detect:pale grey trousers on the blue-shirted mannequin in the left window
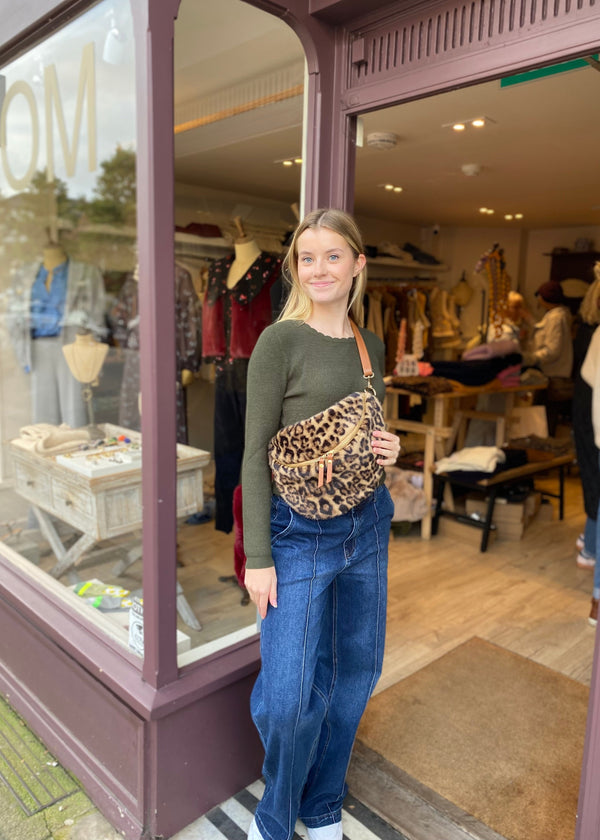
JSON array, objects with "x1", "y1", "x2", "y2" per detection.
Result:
[{"x1": 31, "y1": 335, "x2": 89, "y2": 429}]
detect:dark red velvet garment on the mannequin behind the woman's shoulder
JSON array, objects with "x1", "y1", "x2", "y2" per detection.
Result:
[{"x1": 202, "y1": 253, "x2": 281, "y2": 361}]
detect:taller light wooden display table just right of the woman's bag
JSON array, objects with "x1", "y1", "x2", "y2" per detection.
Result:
[{"x1": 384, "y1": 379, "x2": 546, "y2": 540}]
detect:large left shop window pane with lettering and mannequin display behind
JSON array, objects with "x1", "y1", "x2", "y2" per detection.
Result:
[{"x1": 0, "y1": 0, "x2": 142, "y2": 646}]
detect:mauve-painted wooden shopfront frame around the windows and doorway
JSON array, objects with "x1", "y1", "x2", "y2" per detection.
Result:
[{"x1": 0, "y1": 0, "x2": 600, "y2": 840}]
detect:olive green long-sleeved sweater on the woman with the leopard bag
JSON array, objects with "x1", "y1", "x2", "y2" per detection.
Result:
[{"x1": 242, "y1": 321, "x2": 385, "y2": 569}]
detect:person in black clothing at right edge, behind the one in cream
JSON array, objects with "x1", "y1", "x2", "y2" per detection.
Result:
[{"x1": 572, "y1": 276, "x2": 600, "y2": 569}]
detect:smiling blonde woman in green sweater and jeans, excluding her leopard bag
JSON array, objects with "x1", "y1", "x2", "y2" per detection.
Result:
[{"x1": 242, "y1": 210, "x2": 400, "y2": 840}]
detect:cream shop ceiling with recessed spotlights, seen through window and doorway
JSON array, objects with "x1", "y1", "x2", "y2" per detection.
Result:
[{"x1": 175, "y1": 0, "x2": 600, "y2": 229}]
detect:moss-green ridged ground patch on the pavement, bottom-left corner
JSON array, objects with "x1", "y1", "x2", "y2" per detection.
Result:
[{"x1": 0, "y1": 698, "x2": 80, "y2": 817}]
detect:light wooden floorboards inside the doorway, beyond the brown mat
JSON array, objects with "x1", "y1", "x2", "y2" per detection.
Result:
[{"x1": 377, "y1": 475, "x2": 595, "y2": 691}]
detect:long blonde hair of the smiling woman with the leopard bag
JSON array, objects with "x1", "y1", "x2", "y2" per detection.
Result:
[{"x1": 278, "y1": 208, "x2": 367, "y2": 327}]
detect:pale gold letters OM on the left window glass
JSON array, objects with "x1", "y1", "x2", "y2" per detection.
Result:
[{"x1": 0, "y1": 42, "x2": 97, "y2": 190}]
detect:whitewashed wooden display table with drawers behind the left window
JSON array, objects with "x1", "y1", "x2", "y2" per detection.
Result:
[{"x1": 9, "y1": 423, "x2": 210, "y2": 628}]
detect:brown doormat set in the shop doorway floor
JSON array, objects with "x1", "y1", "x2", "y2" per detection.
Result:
[{"x1": 358, "y1": 637, "x2": 589, "y2": 840}]
